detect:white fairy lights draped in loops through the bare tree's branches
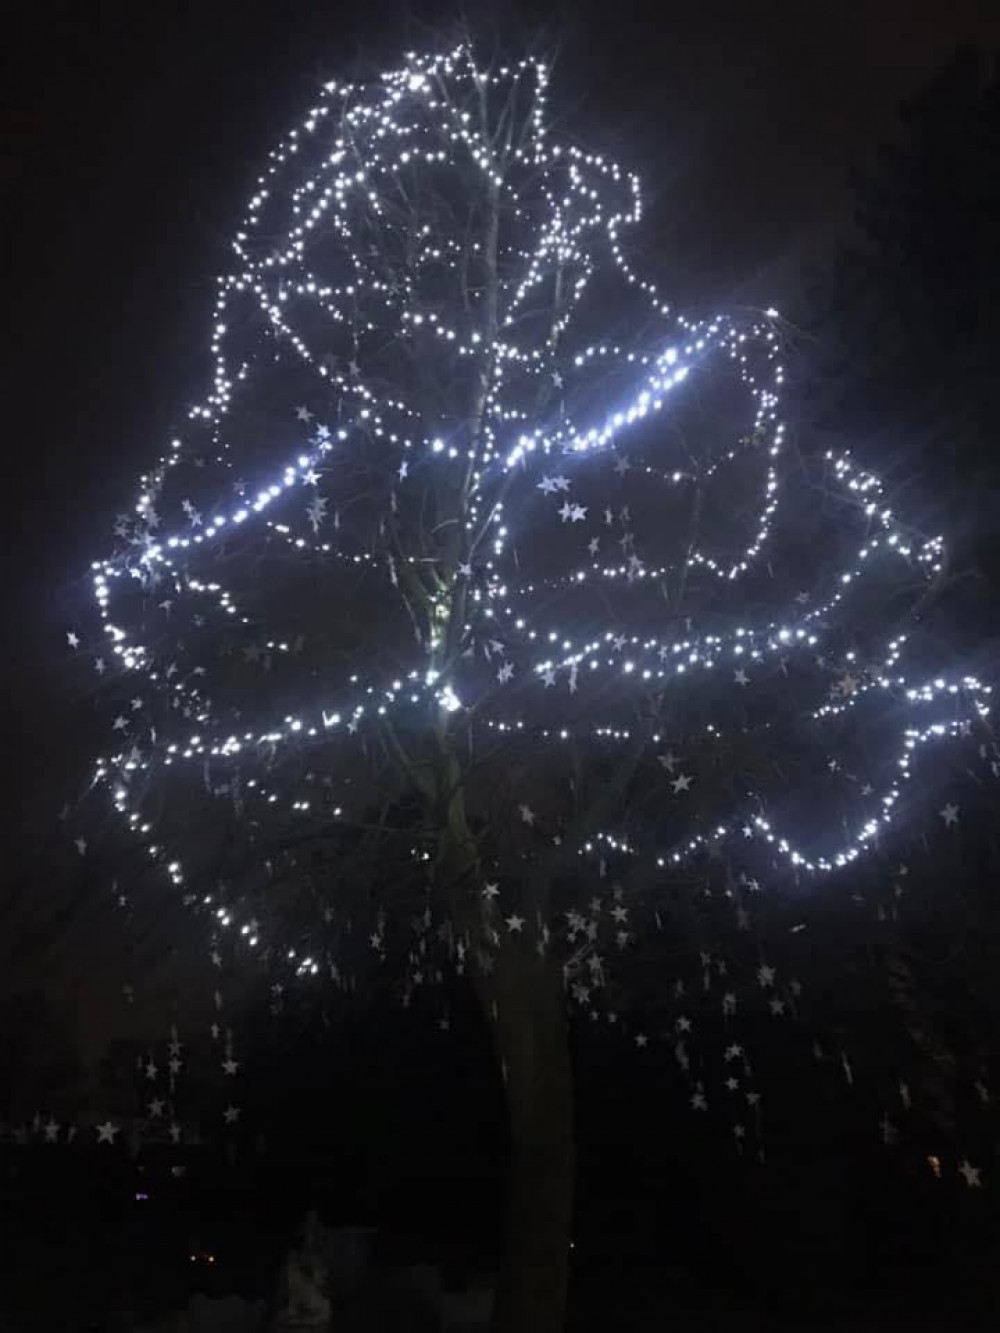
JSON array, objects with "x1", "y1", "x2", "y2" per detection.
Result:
[{"x1": 68, "y1": 47, "x2": 997, "y2": 973}]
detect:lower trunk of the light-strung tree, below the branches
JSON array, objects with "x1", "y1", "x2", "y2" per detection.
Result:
[{"x1": 485, "y1": 940, "x2": 575, "y2": 1333}]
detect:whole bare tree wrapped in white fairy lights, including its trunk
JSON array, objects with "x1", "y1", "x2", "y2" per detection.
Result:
[{"x1": 71, "y1": 45, "x2": 985, "y2": 1333}]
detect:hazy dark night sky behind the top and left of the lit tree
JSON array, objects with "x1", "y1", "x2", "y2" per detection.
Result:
[{"x1": 0, "y1": 0, "x2": 1000, "y2": 865}]
